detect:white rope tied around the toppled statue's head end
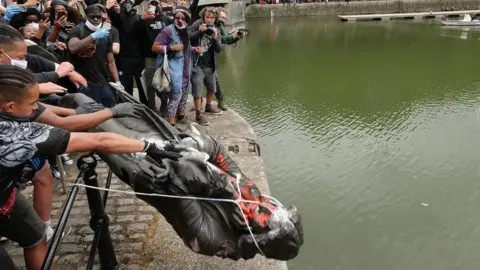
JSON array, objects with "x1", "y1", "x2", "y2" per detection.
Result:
[{"x1": 73, "y1": 174, "x2": 272, "y2": 256}]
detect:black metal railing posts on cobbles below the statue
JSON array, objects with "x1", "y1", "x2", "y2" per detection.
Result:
[{"x1": 42, "y1": 154, "x2": 118, "y2": 270}]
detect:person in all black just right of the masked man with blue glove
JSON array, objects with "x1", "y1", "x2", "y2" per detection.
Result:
[{"x1": 106, "y1": 0, "x2": 148, "y2": 106}]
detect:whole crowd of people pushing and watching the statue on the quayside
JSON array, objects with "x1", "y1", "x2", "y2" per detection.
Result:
[{"x1": 0, "y1": 0, "x2": 247, "y2": 269}]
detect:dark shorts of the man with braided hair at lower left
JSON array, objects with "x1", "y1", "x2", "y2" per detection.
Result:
[{"x1": 0, "y1": 189, "x2": 46, "y2": 248}]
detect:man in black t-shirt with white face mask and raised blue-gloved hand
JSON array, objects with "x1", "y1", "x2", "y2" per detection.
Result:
[{"x1": 68, "y1": 5, "x2": 123, "y2": 108}]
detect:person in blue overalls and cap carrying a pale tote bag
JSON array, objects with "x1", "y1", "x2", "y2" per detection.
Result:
[{"x1": 152, "y1": 7, "x2": 199, "y2": 125}]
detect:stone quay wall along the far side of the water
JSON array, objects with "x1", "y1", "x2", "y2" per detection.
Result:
[{"x1": 246, "y1": 0, "x2": 480, "y2": 18}]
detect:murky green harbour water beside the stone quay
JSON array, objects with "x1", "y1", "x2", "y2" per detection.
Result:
[{"x1": 218, "y1": 18, "x2": 480, "y2": 270}]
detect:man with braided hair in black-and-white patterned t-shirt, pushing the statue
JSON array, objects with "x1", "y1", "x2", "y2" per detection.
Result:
[{"x1": 0, "y1": 65, "x2": 181, "y2": 269}]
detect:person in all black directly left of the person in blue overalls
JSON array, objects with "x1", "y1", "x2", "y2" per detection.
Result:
[{"x1": 132, "y1": 0, "x2": 172, "y2": 110}]
